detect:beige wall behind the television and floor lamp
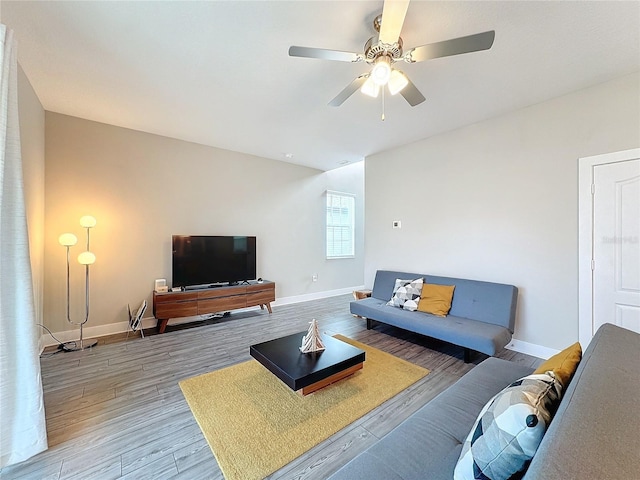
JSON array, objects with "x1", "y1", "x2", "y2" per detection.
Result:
[{"x1": 45, "y1": 112, "x2": 364, "y2": 332}]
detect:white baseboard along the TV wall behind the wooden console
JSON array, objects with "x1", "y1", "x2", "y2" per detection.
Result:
[{"x1": 40, "y1": 285, "x2": 364, "y2": 353}]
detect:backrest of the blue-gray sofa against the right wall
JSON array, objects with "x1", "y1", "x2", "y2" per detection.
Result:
[{"x1": 368, "y1": 270, "x2": 518, "y2": 333}]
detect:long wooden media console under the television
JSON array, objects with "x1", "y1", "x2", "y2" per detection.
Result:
[{"x1": 153, "y1": 280, "x2": 276, "y2": 333}]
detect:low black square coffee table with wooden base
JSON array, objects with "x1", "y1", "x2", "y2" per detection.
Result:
[{"x1": 249, "y1": 331, "x2": 365, "y2": 395}]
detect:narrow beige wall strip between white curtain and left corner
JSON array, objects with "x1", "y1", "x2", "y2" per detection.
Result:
[{"x1": 18, "y1": 67, "x2": 45, "y2": 330}]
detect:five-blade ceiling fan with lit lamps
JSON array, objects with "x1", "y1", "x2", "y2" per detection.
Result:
[{"x1": 289, "y1": 0, "x2": 496, "y2": 109}]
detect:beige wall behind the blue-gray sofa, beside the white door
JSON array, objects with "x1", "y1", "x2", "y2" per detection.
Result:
[{"x1": 365, "y1": 74, "x2": 640, "y2": 349}]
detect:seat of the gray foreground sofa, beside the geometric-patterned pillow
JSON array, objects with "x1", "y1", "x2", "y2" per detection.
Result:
[{"x1": 330, "y1": 358, "x2": 532, "y2": 480}]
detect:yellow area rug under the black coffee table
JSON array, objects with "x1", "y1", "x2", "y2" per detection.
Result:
[{"x1": 180, "y1": 335, "x2": 429, "y2": 480}]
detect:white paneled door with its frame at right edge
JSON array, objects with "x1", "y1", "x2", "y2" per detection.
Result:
[{"x1": 580, "y1": 150, "x2": 640, "y2": 347}]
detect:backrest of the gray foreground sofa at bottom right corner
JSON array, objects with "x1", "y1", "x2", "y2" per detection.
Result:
[{"x1": 524, "y1": 324, "x2": 640, "y2": 480}]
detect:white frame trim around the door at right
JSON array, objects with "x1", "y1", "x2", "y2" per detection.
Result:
[{"x1": 578, "y1": 148, "x2": 640, "y2": 349}]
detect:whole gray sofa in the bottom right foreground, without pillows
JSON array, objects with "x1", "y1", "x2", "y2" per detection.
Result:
[{"x1": 330, "y1": 324, "x2": 640, "y2": 480}]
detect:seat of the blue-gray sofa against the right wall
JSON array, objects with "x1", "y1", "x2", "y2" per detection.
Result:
[{"x1": 351, "y1": 298, "x2": 511, "y2": 355}]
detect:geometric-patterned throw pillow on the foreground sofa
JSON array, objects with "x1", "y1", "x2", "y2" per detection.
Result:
[{"x1": 453, "y1": 373, "x2": 562, "y2": 480}]
